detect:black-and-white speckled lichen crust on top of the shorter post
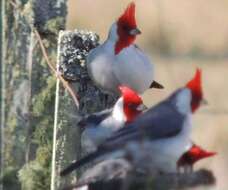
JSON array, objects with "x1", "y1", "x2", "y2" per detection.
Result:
[{"x1": 58, "y1": 30, "x2": 99, "y2": 81}]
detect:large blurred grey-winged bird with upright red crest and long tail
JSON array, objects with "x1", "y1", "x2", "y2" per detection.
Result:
[{"x1": 61, "y1": 69, "x2": 203, "y2": 176}]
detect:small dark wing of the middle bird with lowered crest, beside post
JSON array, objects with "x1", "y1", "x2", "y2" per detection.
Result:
[{"x1": 78, "y1": 108, "x2": 113, "y2": 129}]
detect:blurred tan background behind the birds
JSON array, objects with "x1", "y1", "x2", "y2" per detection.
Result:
[{"x1": 67, "y1": 0, "x2": 228, "y2": 190}]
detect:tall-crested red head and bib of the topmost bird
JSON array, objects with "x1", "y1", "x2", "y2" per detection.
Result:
[{"x1": 115, "y1": 2, "x2": 141, "y2": 54}]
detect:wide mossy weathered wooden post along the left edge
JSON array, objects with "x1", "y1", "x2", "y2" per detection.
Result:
[{"x1": 1, "y1": 0, "x2": 67, "y2": 190}]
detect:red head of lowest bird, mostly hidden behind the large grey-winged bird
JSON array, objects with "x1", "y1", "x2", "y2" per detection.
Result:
[{"x1": 177, "y1": 144, "x2": 217, "y2": 173}]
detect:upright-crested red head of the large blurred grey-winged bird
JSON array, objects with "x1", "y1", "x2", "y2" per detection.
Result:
[{"x1": 186, "y1": 69, "x2": 203, "y2": 112}]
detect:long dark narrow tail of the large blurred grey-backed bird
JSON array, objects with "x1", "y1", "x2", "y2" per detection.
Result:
[{"x1": 60, "y1": 151, "x2": 102, "y2": 176}]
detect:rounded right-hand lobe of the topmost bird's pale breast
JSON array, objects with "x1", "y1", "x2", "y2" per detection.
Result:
[{"x1": 113, "y1": 45, "x2": 154, "y2": 94}]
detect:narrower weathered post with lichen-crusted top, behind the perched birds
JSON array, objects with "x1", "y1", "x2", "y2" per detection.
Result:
[{"x1": 52, "y1": 30, "x2": 115, "y2": 190}]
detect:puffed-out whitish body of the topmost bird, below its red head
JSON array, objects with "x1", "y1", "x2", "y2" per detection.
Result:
[{"x1": 87, "y1": 41, "x2": 154, "y2": 94}]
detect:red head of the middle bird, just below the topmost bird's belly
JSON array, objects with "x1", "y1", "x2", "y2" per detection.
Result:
[{"x1": 119, "y1": 86, "x2": 145, "y2": 122}]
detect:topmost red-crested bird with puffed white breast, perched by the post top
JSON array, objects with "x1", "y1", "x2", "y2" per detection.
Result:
[{"x1": 87, "y1": 2, "x2": 163, "y2": 94}]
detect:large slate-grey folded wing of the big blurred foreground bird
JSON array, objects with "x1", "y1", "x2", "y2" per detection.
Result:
[{"x1": 100, "y1": 92, "x2": 185, "y2": 149}]
